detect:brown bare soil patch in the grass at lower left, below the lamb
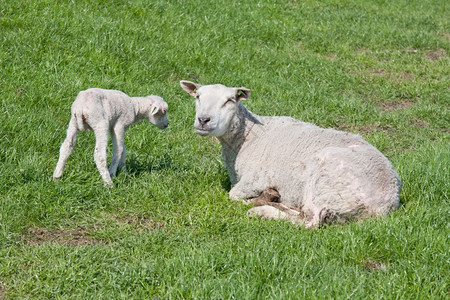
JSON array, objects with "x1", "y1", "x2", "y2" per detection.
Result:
[{"x1": 22, "y1": 227, "x2": 104, "y2": 246}]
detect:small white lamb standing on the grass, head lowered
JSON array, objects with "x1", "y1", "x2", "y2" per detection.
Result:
[{"x1": 53, "y1": 88, "x2": 169, "y2": 187}]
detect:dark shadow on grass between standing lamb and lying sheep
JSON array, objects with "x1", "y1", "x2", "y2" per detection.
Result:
[{"x1": 126, "y1": 153, "x2": 187, "y2": 176}]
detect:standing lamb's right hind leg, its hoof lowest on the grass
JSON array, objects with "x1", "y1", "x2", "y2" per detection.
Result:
[{"x1": 92, "y1": 124, "x2": 113, "y2": 187}]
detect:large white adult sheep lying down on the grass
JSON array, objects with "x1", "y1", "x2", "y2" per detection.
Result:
[{"x1": 180, "y1": 81, "x2": 400, "y2": 228}]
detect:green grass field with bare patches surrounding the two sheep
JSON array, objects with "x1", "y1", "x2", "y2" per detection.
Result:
[{"x1": 0, "y1": 0, "x2": 450, "y2": 299}]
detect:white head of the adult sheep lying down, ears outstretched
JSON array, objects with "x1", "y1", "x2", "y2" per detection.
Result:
[{"x1": 180, "y1": 80, "x2": 250, "y2": 137}]
